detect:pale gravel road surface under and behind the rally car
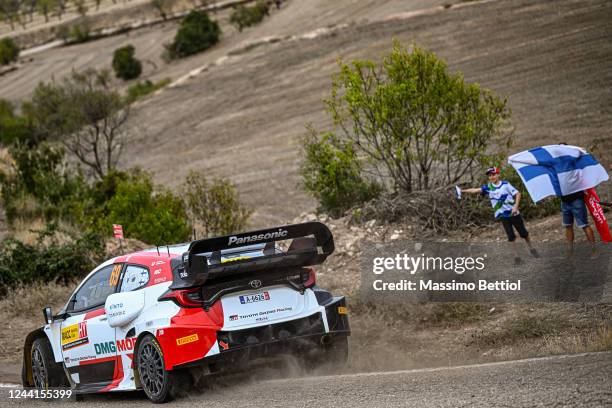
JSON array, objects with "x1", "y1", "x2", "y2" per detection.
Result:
[{"x1": 5, "y1": 352, "x2": 612, "y2": 408}]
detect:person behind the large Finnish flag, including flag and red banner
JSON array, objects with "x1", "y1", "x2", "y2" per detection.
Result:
[{"x1": 508, "y1": 144, "x2": 612, "y2": 257}]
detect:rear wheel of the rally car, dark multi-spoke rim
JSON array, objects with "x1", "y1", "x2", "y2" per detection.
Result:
[{"x1": 135, "y1": 335, "x2": 189, "y2": 404}]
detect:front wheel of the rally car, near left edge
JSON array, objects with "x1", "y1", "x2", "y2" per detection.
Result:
[{"x1": 30, "y1": 337, "x2": 67, "y2": 390}]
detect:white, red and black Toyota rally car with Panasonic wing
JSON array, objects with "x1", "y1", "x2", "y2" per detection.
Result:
[{"x1": 22, "y1": 222, "x2": 350, "y2": 402}]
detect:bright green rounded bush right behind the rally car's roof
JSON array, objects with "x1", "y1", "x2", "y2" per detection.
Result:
[{"x1": 90, "y1": 172, "x2": 191, "y2": 244}]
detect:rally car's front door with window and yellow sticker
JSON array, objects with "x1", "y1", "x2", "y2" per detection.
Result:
[{"x1": 61, "y1": 264, "x2": 123, "y2": 388}]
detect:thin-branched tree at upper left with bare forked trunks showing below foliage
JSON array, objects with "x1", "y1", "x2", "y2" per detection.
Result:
[{"x1": 23, "y1": 69, "x2": 130, "y2": 179}]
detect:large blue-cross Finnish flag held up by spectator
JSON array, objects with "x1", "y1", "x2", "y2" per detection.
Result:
[{"x1": 508, "y1": 145, "x2": 609, "y2": 202}]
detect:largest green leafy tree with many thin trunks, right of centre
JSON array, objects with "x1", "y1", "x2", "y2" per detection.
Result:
[{"x1": 325, "y1": 42, "x2": 511, "y2": 192}]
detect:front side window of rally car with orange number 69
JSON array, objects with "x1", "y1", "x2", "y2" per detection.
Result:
[{"x1": 72, "y1": 264, "x2": 122, "y2": 311}]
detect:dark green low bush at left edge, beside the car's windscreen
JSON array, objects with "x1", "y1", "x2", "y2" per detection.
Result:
[{"x1": 0, "y1": 227, "x2": 104, "y2": 292}]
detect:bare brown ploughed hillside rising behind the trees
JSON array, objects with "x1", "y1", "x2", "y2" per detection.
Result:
[{"x1": 0, "y1": 0, "x2": 612, "y2": 226}]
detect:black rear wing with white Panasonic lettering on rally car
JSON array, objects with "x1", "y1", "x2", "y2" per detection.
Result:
[{"x1": 170, "y1": 222, "x2": 334, "y2": 289}]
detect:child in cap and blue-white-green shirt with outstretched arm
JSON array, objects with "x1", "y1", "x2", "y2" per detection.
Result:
[{"x1": 455, "y1": 167, "x2": 539, "y2": 265}]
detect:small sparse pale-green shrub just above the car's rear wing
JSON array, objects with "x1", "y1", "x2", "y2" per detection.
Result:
[{"x1": 181, "y1": 170, "x2": 252, "y2": 237}]
